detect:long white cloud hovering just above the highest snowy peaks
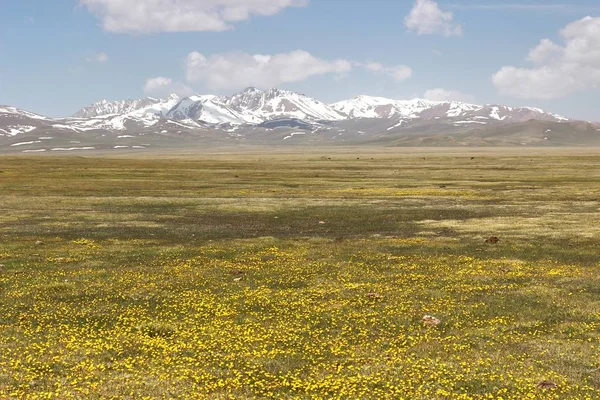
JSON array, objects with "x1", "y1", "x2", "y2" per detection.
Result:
[{"x1": 185, "y1": 50, "x2": 352, "y2": 90}]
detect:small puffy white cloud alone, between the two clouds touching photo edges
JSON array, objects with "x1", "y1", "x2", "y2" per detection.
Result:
[{"x1": 404, "y1": 0, "x2": 462, "y2": 36}]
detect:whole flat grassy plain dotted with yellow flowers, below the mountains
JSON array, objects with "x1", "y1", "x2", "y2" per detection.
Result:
[{"x1": 0, "y1": 150, "x2": 600, "y2": 400}]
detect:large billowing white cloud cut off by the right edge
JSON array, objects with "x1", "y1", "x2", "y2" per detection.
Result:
[{"x1": 492, "y1": 17, "x2": 600, "y2": 99}]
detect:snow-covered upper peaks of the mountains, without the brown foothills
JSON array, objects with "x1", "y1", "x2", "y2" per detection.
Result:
[{"x1": 65, "y1": 87, "x2": 567, "y2": 130}]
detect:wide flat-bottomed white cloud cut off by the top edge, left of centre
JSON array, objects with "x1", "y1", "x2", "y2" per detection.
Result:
[{"x1": 79, "y1": 0, "x2": 308, "y2": 33}]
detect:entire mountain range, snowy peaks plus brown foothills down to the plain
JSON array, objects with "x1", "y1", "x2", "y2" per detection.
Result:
[{"x1": 0, "y1": 87, "x2": 600, "y2": 152}]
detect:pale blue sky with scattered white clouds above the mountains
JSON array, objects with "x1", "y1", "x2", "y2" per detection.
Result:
[{"x1": 0, "y1": 0, "x2": 600, "y2": 121}]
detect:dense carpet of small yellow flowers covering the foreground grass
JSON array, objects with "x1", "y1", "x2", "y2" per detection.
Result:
[{"x1": 0, "y1": 238, "x2": 600, "y2": 400}]
